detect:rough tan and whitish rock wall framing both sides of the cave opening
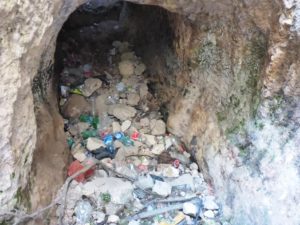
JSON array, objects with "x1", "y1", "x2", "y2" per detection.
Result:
[{"x1": 0, "y1": 0, "x2": 300, "y2": 225}]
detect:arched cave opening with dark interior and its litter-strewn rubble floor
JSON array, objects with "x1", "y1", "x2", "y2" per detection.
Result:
[{"x1": 48, "y1": 1, "x2": 219, "y2": 224}]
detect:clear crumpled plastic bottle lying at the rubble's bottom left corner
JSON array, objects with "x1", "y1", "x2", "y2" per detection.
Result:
[{"x1": 74, "y1": 200, "x2": 93, "y2": 225}]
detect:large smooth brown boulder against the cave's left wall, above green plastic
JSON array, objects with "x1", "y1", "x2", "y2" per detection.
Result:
[{"x1": 62, "y1": 95, "x2": 91, "y2": 118}]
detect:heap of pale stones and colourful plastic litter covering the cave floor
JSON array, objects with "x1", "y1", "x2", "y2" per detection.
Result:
[{"x1": 60, "y1": 41, "x2": 221, "y2": 225}]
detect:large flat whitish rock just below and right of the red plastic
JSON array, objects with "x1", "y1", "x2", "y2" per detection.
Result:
[{"x1": 82, "y1": 177, "x2": 133, "y2": 204}]
